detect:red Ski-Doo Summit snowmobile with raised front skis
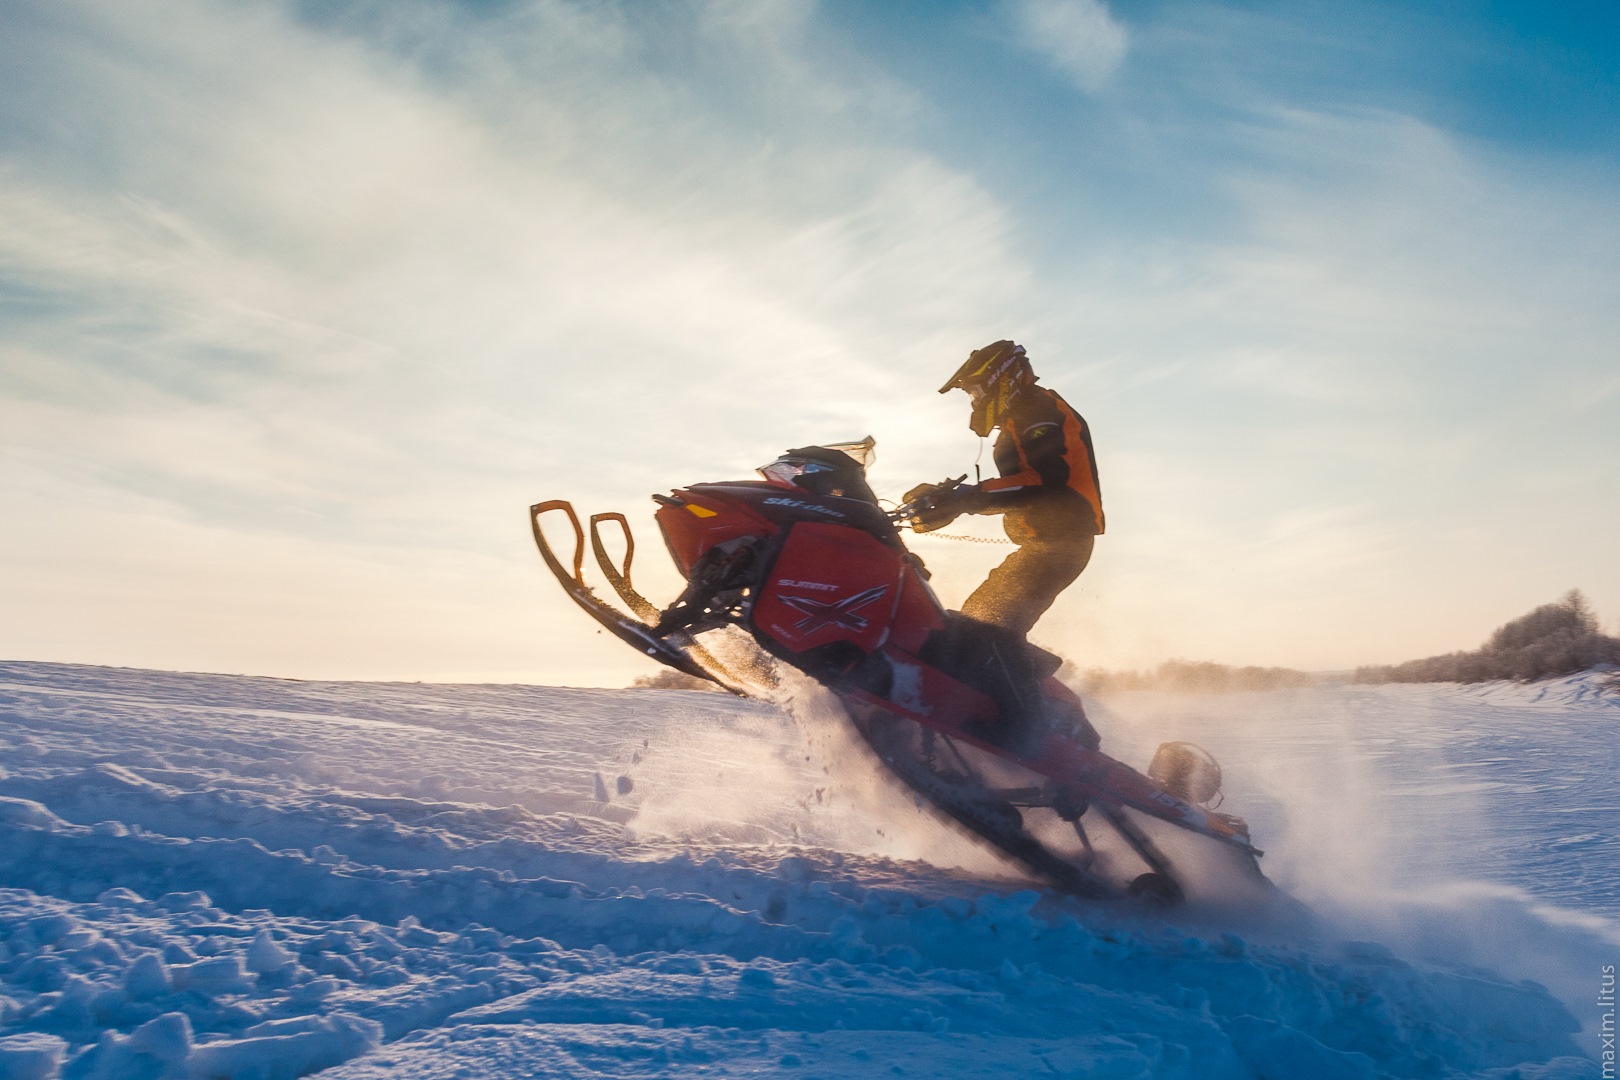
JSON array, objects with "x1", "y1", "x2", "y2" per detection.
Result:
[{"x1": 530, "y1": 437, "x2": 1270, "y2": 904}]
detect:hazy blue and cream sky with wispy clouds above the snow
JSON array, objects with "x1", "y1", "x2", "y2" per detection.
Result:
[{"x1": 0, "y1": 0, "x2": 1620, "y2": 685}]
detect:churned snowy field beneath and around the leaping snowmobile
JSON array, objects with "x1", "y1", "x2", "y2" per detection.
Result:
[{"x1": 0, "y1": 662, "x2": 1620, "y2": 1080}]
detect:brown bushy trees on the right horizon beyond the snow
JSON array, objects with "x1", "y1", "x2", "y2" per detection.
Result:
[{"x1": 1354, "y1": 589, "x2": 1620, "y2": 683}]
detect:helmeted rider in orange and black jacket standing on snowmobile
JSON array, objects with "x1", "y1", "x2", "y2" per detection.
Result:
[{"x1": 906, "y1": 340, "x2": 1103, "y2": 757}]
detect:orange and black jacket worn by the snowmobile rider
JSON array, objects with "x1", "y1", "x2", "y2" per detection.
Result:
[{"x1": 975, "y1": 385, "x2": 1105, "y2": 544}]
